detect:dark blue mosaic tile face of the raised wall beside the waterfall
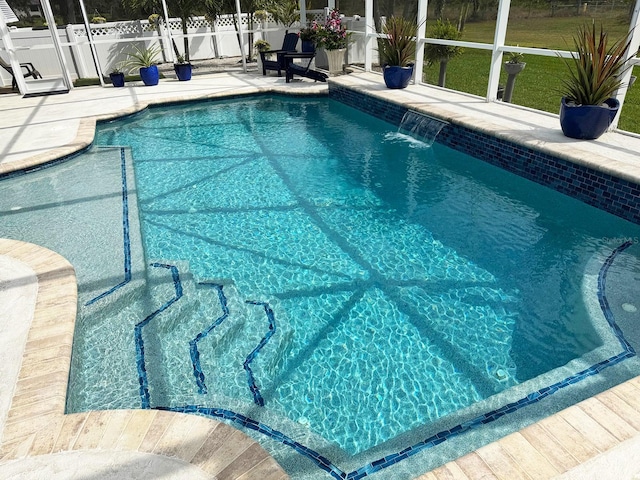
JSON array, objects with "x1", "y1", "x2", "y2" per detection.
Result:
[{"x1": 329, "y1": 83, "x2": 640, "y2": 225}]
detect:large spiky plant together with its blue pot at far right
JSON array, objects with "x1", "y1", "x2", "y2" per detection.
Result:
[{"x1": 560, "y1": 23, "x2": 631, "y2": 140}]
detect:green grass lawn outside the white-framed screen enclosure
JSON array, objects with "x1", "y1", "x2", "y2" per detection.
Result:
[{"x1": 423, "y1": 13, "x2": 640, "y2": 133}]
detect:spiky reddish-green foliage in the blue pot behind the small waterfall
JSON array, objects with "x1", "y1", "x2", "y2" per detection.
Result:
[{"x1": 378, "y1": 16, "x2": 418, "y2": 67}]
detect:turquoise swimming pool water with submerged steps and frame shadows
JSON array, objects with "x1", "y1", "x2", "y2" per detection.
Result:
[{"x1": 1, "y1": 94, "x2": 638, "y2": 478}]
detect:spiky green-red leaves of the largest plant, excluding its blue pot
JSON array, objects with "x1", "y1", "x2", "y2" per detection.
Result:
[{"x1": 561, "y1": 23, "x2": 631, "y2": 105}]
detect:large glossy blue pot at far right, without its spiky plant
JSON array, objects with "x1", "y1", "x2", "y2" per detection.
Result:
[{"x1": 560, "y1": 97, "x2": 620, "y2": 140}]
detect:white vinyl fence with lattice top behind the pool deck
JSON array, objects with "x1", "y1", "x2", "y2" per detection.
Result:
[{"x1": 0, "y1": 10, "x2": 376, "y2": 86}]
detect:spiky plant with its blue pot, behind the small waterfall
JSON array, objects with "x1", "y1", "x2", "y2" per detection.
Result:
[{"x1": 378, "y1": 16, "x2": 418, "y2": 88}]
